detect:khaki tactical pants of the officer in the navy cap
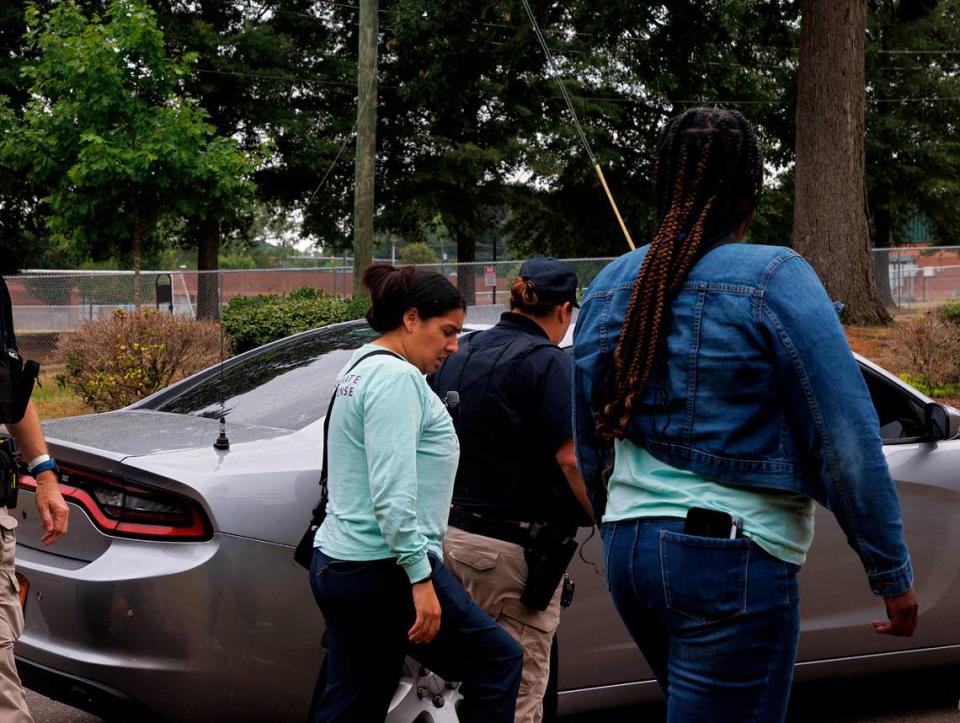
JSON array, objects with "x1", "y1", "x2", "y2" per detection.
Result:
[{"x1": 443, "y1": 527, "x2": 563, "y2": 723}]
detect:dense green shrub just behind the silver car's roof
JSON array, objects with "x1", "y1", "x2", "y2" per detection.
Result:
[{"x1": 222, "y1": 286, "x2": 369, "y2": 354}]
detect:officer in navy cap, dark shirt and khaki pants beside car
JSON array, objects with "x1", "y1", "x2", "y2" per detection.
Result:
[{"x1": 428, "y1": 259, "x2": 592, "y2": 723}]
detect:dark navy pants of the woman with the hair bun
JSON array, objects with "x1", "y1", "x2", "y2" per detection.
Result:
[{"x1": 310, "y1": 550, "x2": 523, "y2": 723}]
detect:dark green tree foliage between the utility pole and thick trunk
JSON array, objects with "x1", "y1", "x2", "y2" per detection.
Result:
[{"x1": 378, "y1": 0, "x2": 797, "y2": 272}]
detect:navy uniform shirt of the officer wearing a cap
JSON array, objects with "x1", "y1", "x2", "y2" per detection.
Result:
[{"x1": 428, "y1": 312, "x2": 582, "y2": 526}]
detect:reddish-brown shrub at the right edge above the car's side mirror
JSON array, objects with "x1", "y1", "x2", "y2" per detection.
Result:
[{"x1": 897, "y1": 314, "x2": 960, "y2": 389}]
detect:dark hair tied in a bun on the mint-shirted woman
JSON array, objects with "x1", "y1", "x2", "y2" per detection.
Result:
[{"x1": 363, "y1": 263, "x2": 467, "y2": 333}]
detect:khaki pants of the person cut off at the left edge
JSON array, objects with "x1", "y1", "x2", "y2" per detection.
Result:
[{"x1": 0, "y1": 507, "x2": 33, "y2": 723}]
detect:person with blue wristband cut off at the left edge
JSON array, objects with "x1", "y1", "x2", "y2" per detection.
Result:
[{"x1": 0, "y1": 277, "x2": 70, "y2": 723}]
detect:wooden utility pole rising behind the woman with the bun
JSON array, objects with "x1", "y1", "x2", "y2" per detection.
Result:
[{"x1": 353, "y1": 0, "x2": 379, "y2": 295}]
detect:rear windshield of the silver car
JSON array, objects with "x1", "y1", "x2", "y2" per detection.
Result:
[{"x1": 157, "y1": 324, "x2": 377, "y2": 430}]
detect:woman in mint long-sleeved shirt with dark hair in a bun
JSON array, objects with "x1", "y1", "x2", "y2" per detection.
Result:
[{"x1": 310, "y1": 264, "x2": 523, "y2": 723}]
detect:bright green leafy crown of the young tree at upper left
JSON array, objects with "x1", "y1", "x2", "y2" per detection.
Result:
[{"x1": 0, "y1": 0, "x2": 253, "y2": 300}]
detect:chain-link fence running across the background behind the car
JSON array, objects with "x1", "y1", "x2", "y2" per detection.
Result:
[{"x1": 6, "y1": 252, "x2": 960, "y2": 365}]
